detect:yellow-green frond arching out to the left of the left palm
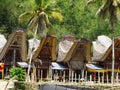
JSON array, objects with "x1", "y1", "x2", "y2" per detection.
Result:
[{"x1": 18, "y1": 11, "x2": 34, "y2": 23}]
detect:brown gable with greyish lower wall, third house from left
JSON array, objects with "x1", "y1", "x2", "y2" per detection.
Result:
[{"x1": 64, "y1": 39, "x2": 91, "y2": 69}]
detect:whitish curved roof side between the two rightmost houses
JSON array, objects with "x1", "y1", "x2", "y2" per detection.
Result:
[{"x1": 92, "y1": 35, "x2": 112, "y2": 61}]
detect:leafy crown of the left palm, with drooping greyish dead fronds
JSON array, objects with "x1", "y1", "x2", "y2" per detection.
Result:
[{"x1": 19, "y1": 0, "x2": 63, "y2": 36}]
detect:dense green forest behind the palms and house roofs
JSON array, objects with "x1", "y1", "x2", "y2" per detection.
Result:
[{"x1": 0, "y1": 0, "x2": 120, "y2": 40}]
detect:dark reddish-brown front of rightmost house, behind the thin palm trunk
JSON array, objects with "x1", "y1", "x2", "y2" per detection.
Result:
[{"x1": 99, "y1": 38, "x2": 120, "y2": 70}]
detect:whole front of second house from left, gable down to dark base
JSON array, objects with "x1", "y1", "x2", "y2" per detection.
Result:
[{"x1": 33, "y1": 35, "x2": 56, "y2": 78}]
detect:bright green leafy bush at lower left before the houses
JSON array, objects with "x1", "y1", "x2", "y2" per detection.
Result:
[{"x1": 10, "y1": 67, "x2": 25, "y2": 81}]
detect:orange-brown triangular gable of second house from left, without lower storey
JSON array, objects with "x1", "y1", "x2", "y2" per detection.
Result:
[{"x1": 33, "y1": 35, "x2": 56, "y2": 60}]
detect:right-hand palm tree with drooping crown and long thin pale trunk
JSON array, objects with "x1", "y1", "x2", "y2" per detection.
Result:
[{"x1": 87, "y1": 0, "x2": 120, "y2": 84}]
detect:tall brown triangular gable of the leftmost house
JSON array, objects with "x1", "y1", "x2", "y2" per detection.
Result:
[{"x1": 0, "y1": 29, "x2": 27, "y2": 65}]
